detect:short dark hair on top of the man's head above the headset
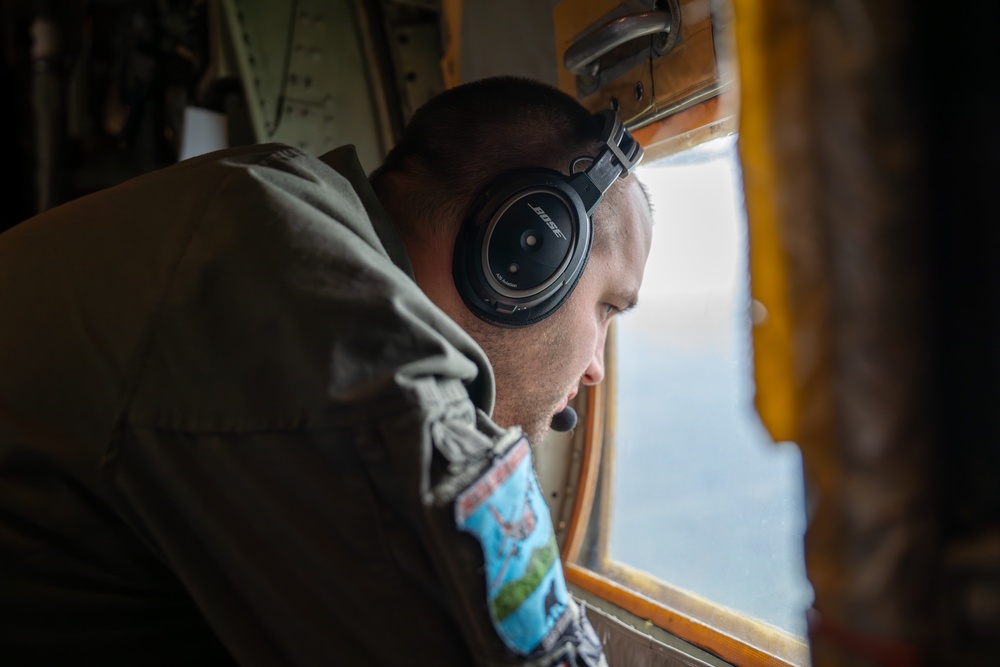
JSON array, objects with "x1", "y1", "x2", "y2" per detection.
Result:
[{"x1": 369, "y1": 76, "x2": 602, "y2": 239}]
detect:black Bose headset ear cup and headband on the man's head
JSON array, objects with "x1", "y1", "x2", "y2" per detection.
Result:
[{"x1": 452, "y1": 110, "x2": 642, "y2": 327}]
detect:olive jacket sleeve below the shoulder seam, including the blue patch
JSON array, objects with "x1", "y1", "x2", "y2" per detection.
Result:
[{"x1": 107, "y1": 378, "x2": 605, "y2": 667}]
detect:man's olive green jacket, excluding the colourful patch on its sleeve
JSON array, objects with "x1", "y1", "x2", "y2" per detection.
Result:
[{"x1": 0, "y1": 144, "x2": 589, "y2": 665}]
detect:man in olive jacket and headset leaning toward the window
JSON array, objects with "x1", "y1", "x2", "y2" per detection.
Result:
[{"x1": 0, "y1": 78, "x2": 651, "y2": 665}]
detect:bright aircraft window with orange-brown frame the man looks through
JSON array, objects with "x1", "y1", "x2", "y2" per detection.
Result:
[{"x1": 570, "y1": 135, "x2": 812, "y2": 664}]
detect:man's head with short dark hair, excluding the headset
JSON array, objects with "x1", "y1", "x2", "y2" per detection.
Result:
[{"x1": 371, "y1": 77, "x2": 651, "y2": 442}]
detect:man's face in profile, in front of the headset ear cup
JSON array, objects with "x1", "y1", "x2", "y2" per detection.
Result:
[{"x1": 473, "y1": 178, "x2": 652, "y2": 444}]
